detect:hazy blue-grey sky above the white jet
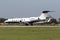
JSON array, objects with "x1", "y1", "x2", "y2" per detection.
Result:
[{"x1": 0, "y1": 0, "x2": 60, "y2": 18}]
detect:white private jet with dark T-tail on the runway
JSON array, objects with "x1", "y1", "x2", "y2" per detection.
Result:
[{"x1": 4, "y1": 11, "x2": 54, "y2": 25}]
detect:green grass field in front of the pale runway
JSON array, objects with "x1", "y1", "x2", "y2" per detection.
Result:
[{"x1": 0, "y1": 27, "x2": 60, "y2": 40}]
